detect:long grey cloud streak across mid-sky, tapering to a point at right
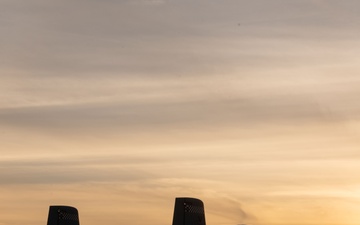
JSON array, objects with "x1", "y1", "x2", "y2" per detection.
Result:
[{"x1": 0, "y1": 98, "x2": 336, "y2": 132}]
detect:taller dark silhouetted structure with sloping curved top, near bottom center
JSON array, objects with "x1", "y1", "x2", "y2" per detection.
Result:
[{"x1": 172, "y1": 198, "x2": 206, "y2": 225}]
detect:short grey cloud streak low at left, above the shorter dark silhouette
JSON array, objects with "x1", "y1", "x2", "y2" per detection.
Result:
[{"x1": 0, "y1": 156, "x2": 156, "y2": 185}]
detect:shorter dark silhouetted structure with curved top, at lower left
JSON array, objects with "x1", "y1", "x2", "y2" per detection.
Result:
[{"x1": 47, "y1": 205, "x2": 80, "y2": 225}]
